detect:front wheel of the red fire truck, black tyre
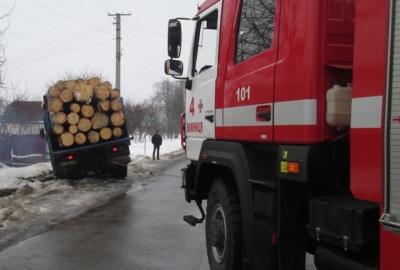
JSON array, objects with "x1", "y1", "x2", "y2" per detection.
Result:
[{"x1": 206, "y1": 179, "x2": 242, "y2": 270}]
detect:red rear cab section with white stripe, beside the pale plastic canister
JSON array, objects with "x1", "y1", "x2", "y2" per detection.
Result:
[{"x1": 274, "y1": 0, "x2": 354, "y2": 143}]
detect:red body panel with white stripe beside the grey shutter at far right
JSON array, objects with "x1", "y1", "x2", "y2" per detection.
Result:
[{"x1": 351, "y1": 0, "x2": 400, "y2": 270}]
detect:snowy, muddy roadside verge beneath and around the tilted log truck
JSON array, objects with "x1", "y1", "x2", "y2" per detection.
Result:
[{"x1": 0, "y1": 139, "x2": 184, "y2": 250}]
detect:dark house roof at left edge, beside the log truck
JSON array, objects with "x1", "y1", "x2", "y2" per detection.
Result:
[{"x1": 3, "y1": 101, "x2": 43, "y2": 123}]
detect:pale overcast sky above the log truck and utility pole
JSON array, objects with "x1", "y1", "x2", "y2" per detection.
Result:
[{"x1": 0, "y1": 0, "x2": 203, "y2": 101}]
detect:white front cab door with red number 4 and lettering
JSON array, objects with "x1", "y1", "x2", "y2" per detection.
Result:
[{"x1": 185, "y1": 1, "x2": 221, "y2": 160}]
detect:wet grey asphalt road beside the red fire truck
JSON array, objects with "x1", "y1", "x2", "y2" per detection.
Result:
[{"x1": 0, "y1": 158, "x2": 316, "y2": 270}]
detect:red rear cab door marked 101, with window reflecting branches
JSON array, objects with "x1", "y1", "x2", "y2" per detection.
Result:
[{"x1": 221, "y1": 0, "x2": 280, "y2": 142}]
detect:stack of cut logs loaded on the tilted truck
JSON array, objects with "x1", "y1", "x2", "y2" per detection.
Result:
[{"x1": 47, "y1": 77, "x2": 125, "y2": 147}]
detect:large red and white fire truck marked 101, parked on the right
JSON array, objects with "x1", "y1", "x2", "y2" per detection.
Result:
[{"x1": 165, "y1": 0, "x2": 400, "y2": 270}]
